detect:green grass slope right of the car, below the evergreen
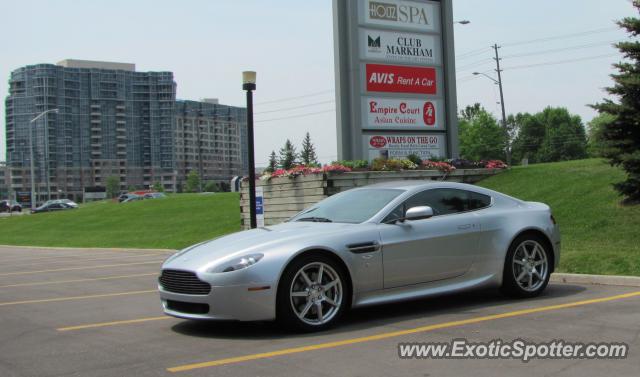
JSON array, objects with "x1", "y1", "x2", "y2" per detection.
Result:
[{"x1": 479, "y1": 159, "x2": 640, "y2": 276}]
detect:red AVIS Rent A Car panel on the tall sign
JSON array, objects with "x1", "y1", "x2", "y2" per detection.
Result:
[{"x1": 365, "y1": 64, "x2": 438, "y2": 95}]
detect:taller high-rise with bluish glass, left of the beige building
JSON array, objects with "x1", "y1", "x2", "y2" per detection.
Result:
[{"x1": 6, "y1": 60, "x2": 176, "y2": 200}]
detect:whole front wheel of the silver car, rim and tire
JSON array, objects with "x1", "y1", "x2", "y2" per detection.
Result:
[{"x1": 276, "y1": 254, "x2": 350, "y2": 331}]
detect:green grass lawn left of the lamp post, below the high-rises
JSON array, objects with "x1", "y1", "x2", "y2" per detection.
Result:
[{"x1": 0, "y1": 193, "x2": 240, "y2": 249}]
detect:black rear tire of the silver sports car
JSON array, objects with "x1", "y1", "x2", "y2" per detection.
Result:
[{"x1": 500, "y1": 234, "x2": 553, "y2": 298}]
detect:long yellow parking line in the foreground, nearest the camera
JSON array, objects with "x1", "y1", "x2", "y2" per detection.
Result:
[{"x1": 167, "y1": 291, "x2": 640, "y2": 372}]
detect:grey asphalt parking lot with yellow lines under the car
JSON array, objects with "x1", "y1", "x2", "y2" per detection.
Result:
[{"x1": 0, "y1": 247, "x2": 640, "y2": 377}]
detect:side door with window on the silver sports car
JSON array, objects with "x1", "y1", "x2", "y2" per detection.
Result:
[{"x1": 379, "y1": 188, "x2": 480, "y2": 288}]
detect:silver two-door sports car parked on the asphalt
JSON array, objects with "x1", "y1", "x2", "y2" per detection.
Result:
[{"x1": 159, "y1": 181, "x2": 560, "y2": 330}]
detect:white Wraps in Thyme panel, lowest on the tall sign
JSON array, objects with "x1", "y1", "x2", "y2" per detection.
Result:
[{"x1": 363, "y1": 134, "x2": 445, "y2": 160}]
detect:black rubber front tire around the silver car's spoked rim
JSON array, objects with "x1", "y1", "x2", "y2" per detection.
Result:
[{"x1": 276, "y1": 253, "x2": 351, "y2": 332}]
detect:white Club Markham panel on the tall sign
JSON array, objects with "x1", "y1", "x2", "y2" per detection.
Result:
[{"x1": 360, "y1": 29, "x2": 442, "y2": 65}]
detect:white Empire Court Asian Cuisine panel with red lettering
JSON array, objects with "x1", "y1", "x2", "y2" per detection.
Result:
[{"x1": 362, "y1": 97, "x2": 444, "y2": 130}]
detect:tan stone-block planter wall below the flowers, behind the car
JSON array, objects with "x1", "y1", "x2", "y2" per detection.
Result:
[{"x1": 240, "y1": 169, "x2": 503, "y2": 229}]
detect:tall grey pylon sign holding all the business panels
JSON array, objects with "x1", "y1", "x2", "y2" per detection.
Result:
[{"x1": 333, "y1": 0, "x2": 458, "y2": 160}]
